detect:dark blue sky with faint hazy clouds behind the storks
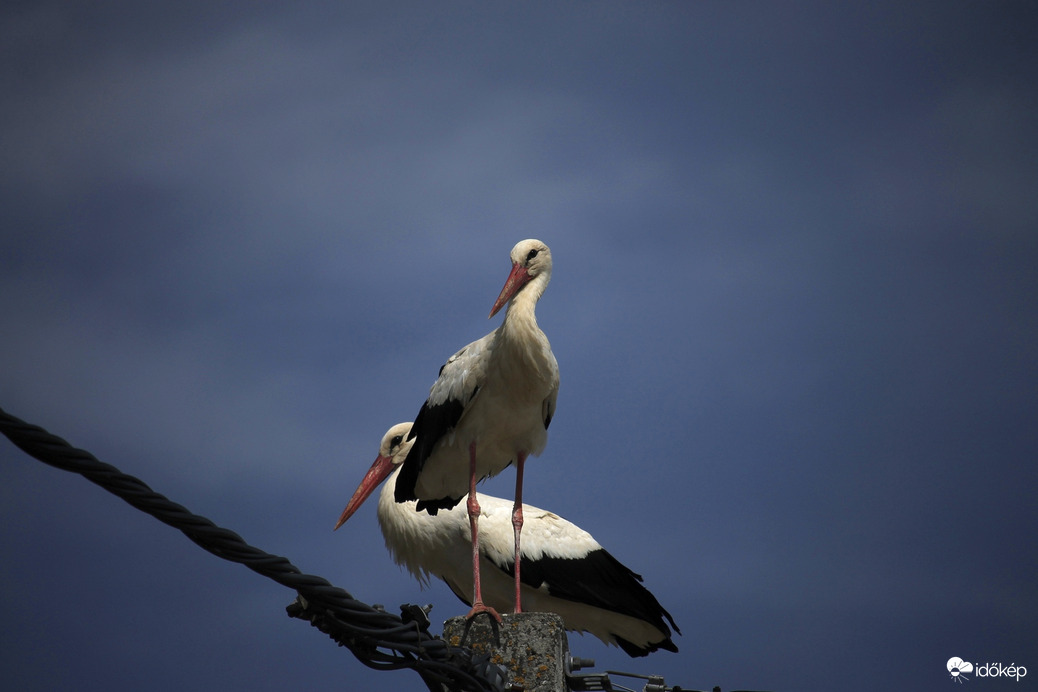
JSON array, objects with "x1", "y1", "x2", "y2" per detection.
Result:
[{"x1": 0, "y1": 2, "x2": 1038, "y2": 691}]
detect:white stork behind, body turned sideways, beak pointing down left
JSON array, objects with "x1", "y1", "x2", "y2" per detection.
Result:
[{"x1": 335, "y1": 423, "x2": 681, "y2": 657}]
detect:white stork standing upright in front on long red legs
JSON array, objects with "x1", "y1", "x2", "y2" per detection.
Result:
[{"x1": 395, "y1": 240, "x2": 558, "y2": 620}]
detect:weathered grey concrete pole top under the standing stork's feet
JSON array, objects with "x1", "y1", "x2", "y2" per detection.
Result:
[{"x1": 443, "y1": 613, "x2": 569, "y2": 692}]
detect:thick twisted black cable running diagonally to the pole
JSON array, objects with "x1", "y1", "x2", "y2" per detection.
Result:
[{"x1": 0, "y1": 409, "x2": 502, "y2": 692}]
